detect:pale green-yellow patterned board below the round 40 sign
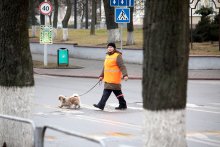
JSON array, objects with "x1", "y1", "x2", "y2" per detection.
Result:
[{"x1": 40, "y1": 25, "x2": 53, "y2": 44}]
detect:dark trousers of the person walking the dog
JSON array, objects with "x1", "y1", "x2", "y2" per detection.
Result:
[{"x1": 98, "y1": 89, "x2": 127, "y2": 108}]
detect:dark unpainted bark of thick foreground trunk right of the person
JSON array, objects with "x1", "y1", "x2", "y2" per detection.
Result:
[{"x1": 143, "y1": 0, "x2": 189, "y2": 110}]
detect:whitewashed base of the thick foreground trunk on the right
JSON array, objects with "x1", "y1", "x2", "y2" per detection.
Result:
[{"x1": 143, "y1": 109, "x2": 187, "y2": 147}]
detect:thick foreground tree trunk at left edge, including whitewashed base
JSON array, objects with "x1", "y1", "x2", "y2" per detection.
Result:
[{"x1": 0, "y1": 0, "x2": 34, "y2": 147}]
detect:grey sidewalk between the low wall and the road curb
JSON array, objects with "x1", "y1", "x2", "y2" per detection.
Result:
[{"x1": 32, "y1": 54, "x2": 220, "y2": 80}]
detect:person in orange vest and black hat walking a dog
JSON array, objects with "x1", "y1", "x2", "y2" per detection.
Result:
[{"x1": 93, "y1": 43, "x2": 128, "y2": 110}]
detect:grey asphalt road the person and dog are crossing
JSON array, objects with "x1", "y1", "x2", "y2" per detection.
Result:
[{"x1": 33, "y1": 75, "x2": 220, "y2": 147}]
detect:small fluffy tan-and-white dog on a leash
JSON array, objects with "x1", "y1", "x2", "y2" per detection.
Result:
[{"x1": 59, "y1": 94, "x2": 80, "y2": 109}]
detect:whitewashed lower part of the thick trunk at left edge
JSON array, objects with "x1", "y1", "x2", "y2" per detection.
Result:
[{"x1": 0, "y1": 86, "x2": 34, "y2": 147}]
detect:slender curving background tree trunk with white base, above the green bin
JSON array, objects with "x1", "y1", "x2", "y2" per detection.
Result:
[{"x1": 62, "y1": 0, "x2": 72, "y2": 41}]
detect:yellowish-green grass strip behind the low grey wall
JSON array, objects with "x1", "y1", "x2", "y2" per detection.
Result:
[{"x1": 29, "y1": 28, "x2": 220, "y2": 55}]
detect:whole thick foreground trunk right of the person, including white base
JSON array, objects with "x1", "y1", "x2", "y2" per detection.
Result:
[{"x1": 142, "y1": 0, "x2": 189, "y2": 147}]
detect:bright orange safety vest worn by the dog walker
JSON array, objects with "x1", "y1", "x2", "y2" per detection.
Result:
[{"x1": 104, "y1": 53, "x2": 122, "y2": 84}]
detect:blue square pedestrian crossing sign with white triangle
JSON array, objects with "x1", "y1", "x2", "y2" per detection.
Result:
[{"x1": 115, "y1": 8, "x2": 130, "y2": 23}]
